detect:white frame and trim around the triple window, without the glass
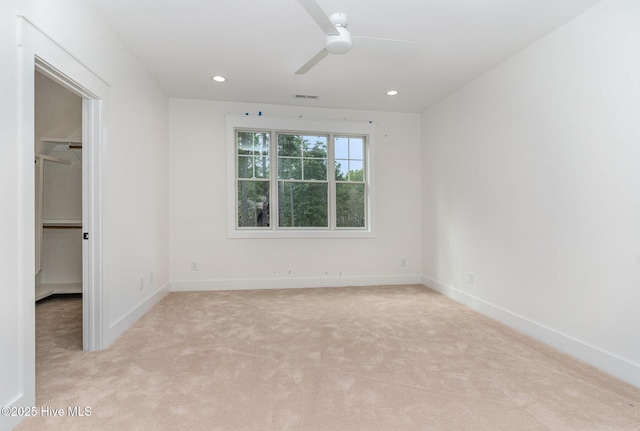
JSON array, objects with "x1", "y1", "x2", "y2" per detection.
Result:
[{"x1": 226, "y1": 115, "x2": 375, "y2": 238}]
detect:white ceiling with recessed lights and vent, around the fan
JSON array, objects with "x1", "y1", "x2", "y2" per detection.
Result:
[{"x1": 86, "y1": 0, "x2": 600, "y2": 112}]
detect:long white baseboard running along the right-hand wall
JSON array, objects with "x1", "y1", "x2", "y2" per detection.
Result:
[{"x1": 422, "y1": 276, "x2": 640, "y2": 387}]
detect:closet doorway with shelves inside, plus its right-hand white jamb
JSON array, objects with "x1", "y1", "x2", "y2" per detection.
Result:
[{"x1": 33, "y1": 57, "x2": 102, "y2": 350}]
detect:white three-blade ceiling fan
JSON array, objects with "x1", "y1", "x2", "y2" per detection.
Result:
[{"x1": 296, "y1": 0, "x2": 417, "y2": 75}]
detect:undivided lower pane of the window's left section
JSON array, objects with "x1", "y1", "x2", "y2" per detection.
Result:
[{"x1": 237, "y1": 180, "x2": 269, "y2": 227}]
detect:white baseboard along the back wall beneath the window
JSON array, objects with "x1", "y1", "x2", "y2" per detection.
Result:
[{"x1": 171, "y1": 274, "x2": 420, "y2": 292}]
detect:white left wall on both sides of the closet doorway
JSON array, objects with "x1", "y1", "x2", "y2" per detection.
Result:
[{"x1": 0, "y1": 0, "x2": 169, "y2": 429}]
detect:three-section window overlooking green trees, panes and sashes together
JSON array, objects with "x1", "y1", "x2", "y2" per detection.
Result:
[{"x1": 227, "y1": 118, "x2": 372, "y2": 237}]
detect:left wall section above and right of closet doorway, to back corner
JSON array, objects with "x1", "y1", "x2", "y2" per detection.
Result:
[{"x1": 20, "y1": 0, "x2": 169, "y2": 342}]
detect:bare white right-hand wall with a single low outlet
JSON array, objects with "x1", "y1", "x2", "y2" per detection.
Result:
[{"x1": 422, "y1": 0, "x2": 640, "y2": 386}]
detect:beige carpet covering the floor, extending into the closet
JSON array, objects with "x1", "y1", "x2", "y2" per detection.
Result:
[{"x1": 18, "y1": 286, "x2": 640, "y2": 431}]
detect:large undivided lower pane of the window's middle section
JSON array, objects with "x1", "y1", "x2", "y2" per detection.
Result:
[{"x1": 278, "y1": 181, "x2": 329, "y2": 227}]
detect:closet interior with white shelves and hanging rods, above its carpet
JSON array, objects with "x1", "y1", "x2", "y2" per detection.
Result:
[{"x1": 34, "y1": 73, "x2": 82, "y2": 301}]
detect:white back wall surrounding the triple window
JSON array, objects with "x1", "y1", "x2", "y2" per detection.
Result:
[{"x1": 170, "y1": 99, "x2": 420, "y2": 290}]
